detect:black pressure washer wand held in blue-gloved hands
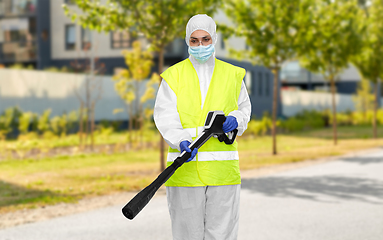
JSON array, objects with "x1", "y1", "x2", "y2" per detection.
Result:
[{"x1": 122, "y1": 111, "x2": 238, "y2": 220}]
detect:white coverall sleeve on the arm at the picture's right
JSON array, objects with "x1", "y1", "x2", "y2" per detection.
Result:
[{"x1": 229, "y1": 81, "x2": 251, "y2": 136}]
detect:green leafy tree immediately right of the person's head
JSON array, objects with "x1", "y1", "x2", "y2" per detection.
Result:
[{"x1": 224, "y1": 0, "x2": 309, "y2": 155}]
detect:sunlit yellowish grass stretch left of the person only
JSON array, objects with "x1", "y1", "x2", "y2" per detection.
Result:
[{"x1": 0, "y1": 150, "x2": 158, "y2": 212}]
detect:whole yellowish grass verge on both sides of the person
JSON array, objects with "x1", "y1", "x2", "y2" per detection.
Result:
[{"x1": 0, "y1": 124, "x2": 383, "y2": 212}]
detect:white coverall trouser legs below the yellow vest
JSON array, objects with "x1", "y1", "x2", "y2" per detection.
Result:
[{"x1": 166, "y1": 185, "x2": 241, "y2": 240}]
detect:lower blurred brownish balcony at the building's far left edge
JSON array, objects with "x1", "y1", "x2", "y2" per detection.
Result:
[{"x1": 0, "y1": 41, "x2": 37, "y2": 63}]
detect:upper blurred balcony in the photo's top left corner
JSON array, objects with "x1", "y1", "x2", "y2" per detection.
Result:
[{"x1": 0, "y1": 0, "x2": 37, "y2": 18}]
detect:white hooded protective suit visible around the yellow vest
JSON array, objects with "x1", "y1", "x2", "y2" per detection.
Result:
[{"x1": 154, "y1": 14, "x2": 251, "y2": 240}]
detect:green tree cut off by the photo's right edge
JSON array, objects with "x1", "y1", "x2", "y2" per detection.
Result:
[{"x1": 351, "y1": 0, "x2": 383, "y2": 138}]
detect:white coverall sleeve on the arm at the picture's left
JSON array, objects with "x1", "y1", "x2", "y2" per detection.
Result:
[{"x1": 153, "y1": 79, "x2": 192, "y2": 150}]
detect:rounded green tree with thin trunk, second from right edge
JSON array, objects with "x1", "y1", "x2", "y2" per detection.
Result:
[{"x1": 300, "y1": 0, "x2": 362, "y2": 145}]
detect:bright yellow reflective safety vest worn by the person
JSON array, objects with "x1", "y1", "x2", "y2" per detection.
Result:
[{"x1": 161, "y1": 59, "x2": 246, "y2": 187}]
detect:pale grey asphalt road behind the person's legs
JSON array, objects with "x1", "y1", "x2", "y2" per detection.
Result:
[{"x1": 0, "y1": 149, "x2": 383, "y2": 240}]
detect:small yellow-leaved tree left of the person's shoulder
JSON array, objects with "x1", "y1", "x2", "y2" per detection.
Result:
[{"x1": 113, "y1": 41, "x2": 159, "y2": 147}]
